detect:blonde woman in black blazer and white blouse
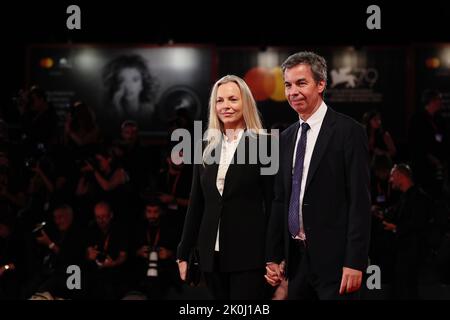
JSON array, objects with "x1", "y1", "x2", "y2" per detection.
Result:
[{"x1": 177, "y1": 75, "x2": 272, "y2": 300}]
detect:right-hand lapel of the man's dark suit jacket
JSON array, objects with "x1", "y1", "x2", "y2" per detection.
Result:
[{"x1": 304, "y1": 108, "x2": 335, "y2": 192}]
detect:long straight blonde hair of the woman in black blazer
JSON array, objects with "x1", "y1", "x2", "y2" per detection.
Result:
[{"x1": 203, "y1": 75, "x2": 263, "y2": 162}]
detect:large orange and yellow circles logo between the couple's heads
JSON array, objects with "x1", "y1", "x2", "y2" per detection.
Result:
[{"x1": 244, "y1": 67, "x2": 286, "y2": 102}]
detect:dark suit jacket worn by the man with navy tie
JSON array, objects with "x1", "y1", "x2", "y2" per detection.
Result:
[{"x1": 267, "y1": 108, "x2": 370, "y2": 281}]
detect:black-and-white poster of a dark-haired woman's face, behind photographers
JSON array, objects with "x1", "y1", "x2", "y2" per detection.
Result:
[{"x1": 28, "y1": 45, "x2": 213, "y2": 135}]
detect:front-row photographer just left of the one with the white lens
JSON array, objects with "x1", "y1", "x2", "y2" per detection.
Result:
[{"x1": 86, "y1": 202, "x2": 127, "y2": 299}]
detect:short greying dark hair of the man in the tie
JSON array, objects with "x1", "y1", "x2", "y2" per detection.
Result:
[{"x1": 281, "y1": 51, "x2": 327, "y2": 84}]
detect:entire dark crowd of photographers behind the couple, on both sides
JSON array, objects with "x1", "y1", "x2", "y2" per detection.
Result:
[{"x1": 0, "y1": 87, "x2": 450, "y2": 299}]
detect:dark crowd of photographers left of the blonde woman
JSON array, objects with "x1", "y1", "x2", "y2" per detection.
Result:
[{"x1": 0, "y1": 87, "x2": 192, "y2": 299}]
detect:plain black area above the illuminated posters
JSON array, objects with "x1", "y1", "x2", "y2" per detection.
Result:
[{"x1": 0, "y1": 0, "x2": 450, "y2": 139}]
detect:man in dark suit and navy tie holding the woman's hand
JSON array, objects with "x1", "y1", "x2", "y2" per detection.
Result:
[{"x1": 266, "y1": 52, "x2": 370, "y2": 299}]
